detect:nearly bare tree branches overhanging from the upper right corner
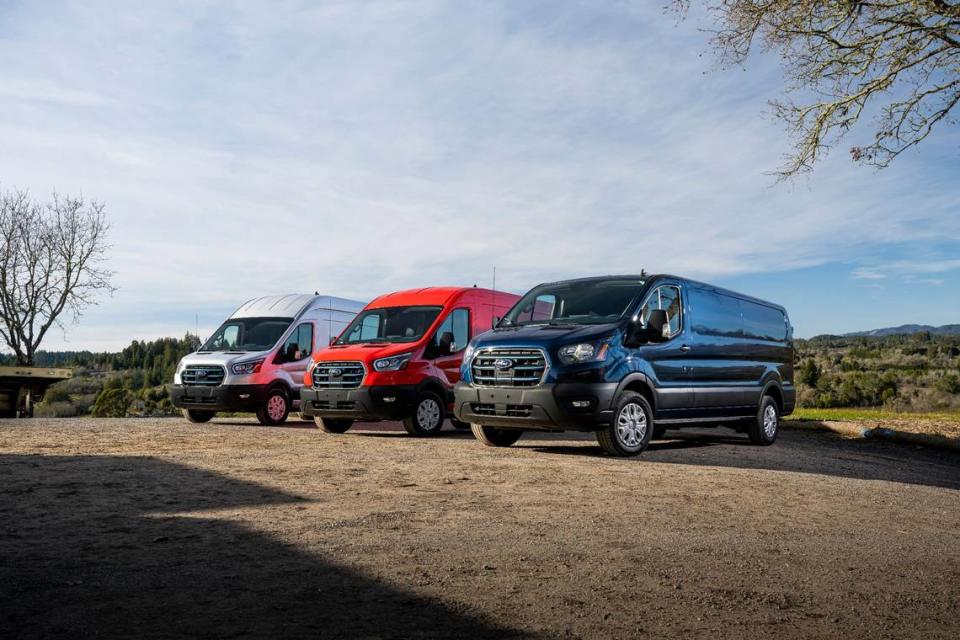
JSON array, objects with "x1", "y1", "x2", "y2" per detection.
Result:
[{"x1": 670, "y1": 0, "x2": 960, "y2": 178}]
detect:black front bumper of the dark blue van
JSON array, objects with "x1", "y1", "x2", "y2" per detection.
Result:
[{"x1": 454, "y1": 382, "x2": 617, "y2": 431}]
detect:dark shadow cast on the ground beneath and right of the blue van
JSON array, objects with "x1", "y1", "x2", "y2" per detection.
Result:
[{"x1": 515, "y1": 428, "x2": 960, "y2": 489}]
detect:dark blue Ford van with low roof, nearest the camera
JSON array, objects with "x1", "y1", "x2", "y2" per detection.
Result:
[{"x1": 454, "y1": 274, "x2": 796, "y2": 456}]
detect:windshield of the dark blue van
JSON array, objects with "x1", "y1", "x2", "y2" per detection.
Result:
[{"x1": 500, "y1": 279, "x2": 646, "y2": 327}]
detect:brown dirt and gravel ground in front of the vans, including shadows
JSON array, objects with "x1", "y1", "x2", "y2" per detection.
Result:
[{"x1": 0, "y1": 419, "x2": 960, "y2": 639}]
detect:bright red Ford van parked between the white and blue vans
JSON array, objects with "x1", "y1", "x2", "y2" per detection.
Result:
[{"x1": 300, "y1": 287, "x2": 519, "y2": 436}]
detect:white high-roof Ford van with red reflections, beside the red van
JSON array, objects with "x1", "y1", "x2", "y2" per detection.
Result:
[{"x1": 169, "y1": 294, "x2": 366, "y2": 425}]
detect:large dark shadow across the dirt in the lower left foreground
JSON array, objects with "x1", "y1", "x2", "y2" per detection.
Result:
[{"x1": 0, "y1": 455, "x2": 526, "y2": 638}]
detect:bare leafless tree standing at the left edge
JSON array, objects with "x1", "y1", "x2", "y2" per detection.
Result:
[{"x1": 0, "y1": 191, "x2": 114, "y2": 366}]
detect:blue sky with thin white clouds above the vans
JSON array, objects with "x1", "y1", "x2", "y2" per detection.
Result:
[{"x1": 0, "y1": 0, "x2": 960, "y2": 350}]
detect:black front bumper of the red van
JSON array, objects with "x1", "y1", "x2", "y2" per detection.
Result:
[{"x1": 300, "y1": 385, "x2": 417, "y2": 420}]
